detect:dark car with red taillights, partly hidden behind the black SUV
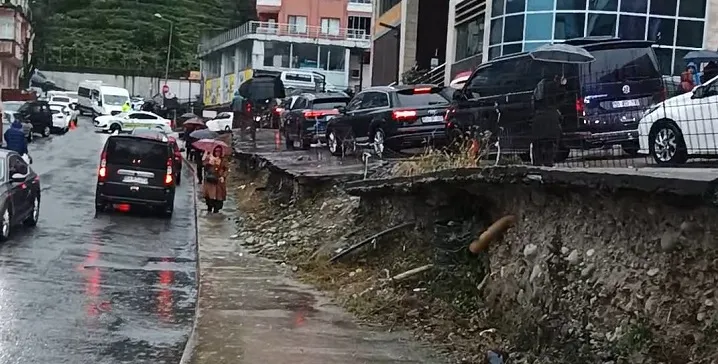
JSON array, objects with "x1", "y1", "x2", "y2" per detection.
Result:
[{"x1": 283, "y1": 92, "x2": 349, "y2": 149}]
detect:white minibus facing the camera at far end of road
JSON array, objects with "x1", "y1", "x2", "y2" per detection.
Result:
[{"x1": 77, "y1": 81, "x2": 130, "y2": 115}]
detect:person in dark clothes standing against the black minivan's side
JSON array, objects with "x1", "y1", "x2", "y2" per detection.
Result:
[{"x1": 530, "y1": 75, "x2": 567, "y2": 167}]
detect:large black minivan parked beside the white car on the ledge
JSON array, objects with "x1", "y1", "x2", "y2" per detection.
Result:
[{"x1": 446, "y1": 37, "x2": 665, "y2": 161}]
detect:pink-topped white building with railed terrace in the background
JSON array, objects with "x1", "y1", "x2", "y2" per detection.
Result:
[{"x1": 199, "y1": 0, "x2": 372, "y2": 107}]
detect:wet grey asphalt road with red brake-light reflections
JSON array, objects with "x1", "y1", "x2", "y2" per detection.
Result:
[{"x1": 0, "y1": 119, "x2": 196, "y2": 364}]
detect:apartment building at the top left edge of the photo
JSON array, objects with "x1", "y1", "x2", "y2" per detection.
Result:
[{"x1": 0, "y1": 0, "x2": 32, "y2": 88}]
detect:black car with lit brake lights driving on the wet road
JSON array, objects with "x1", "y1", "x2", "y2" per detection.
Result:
[{"x1": 95, "y1": 135, "x2": 176, "y2": 217}]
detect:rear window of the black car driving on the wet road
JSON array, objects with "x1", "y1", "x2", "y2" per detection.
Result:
[{"x1": 107, "y1": 137, "x2": 169, "y2": 169}]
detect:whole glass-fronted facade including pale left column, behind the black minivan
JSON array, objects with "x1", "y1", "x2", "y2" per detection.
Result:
[{"x1": 445, "y1": 0, "x2": 718, "y2": 82}]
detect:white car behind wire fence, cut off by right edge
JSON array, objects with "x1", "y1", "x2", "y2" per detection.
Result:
[{"x1": 638, "y1": 77, "x2": 718, "y2": 164}]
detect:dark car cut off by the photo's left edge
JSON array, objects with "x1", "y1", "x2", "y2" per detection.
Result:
[{"x1": 0, "y1": 149, "x2": 40, "y2": 241}]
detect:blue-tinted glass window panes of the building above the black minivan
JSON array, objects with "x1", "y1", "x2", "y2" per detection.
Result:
[{"x1": 487, "y1": 0, "x2": 706, "y2": 74}]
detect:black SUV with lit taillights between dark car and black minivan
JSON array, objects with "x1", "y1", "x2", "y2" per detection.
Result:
[{"x1": 326, "y1": 85, "x2": 449, "y2": 155}]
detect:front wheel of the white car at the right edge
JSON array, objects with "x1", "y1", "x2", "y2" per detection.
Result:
[{"x1": 648, "y1": 122, "x2": 688, "y2": 164}]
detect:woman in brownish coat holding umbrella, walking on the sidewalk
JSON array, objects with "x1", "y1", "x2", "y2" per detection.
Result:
[{"x1": 195, "y1": 139, "x2": 229, "y2": 213}]
